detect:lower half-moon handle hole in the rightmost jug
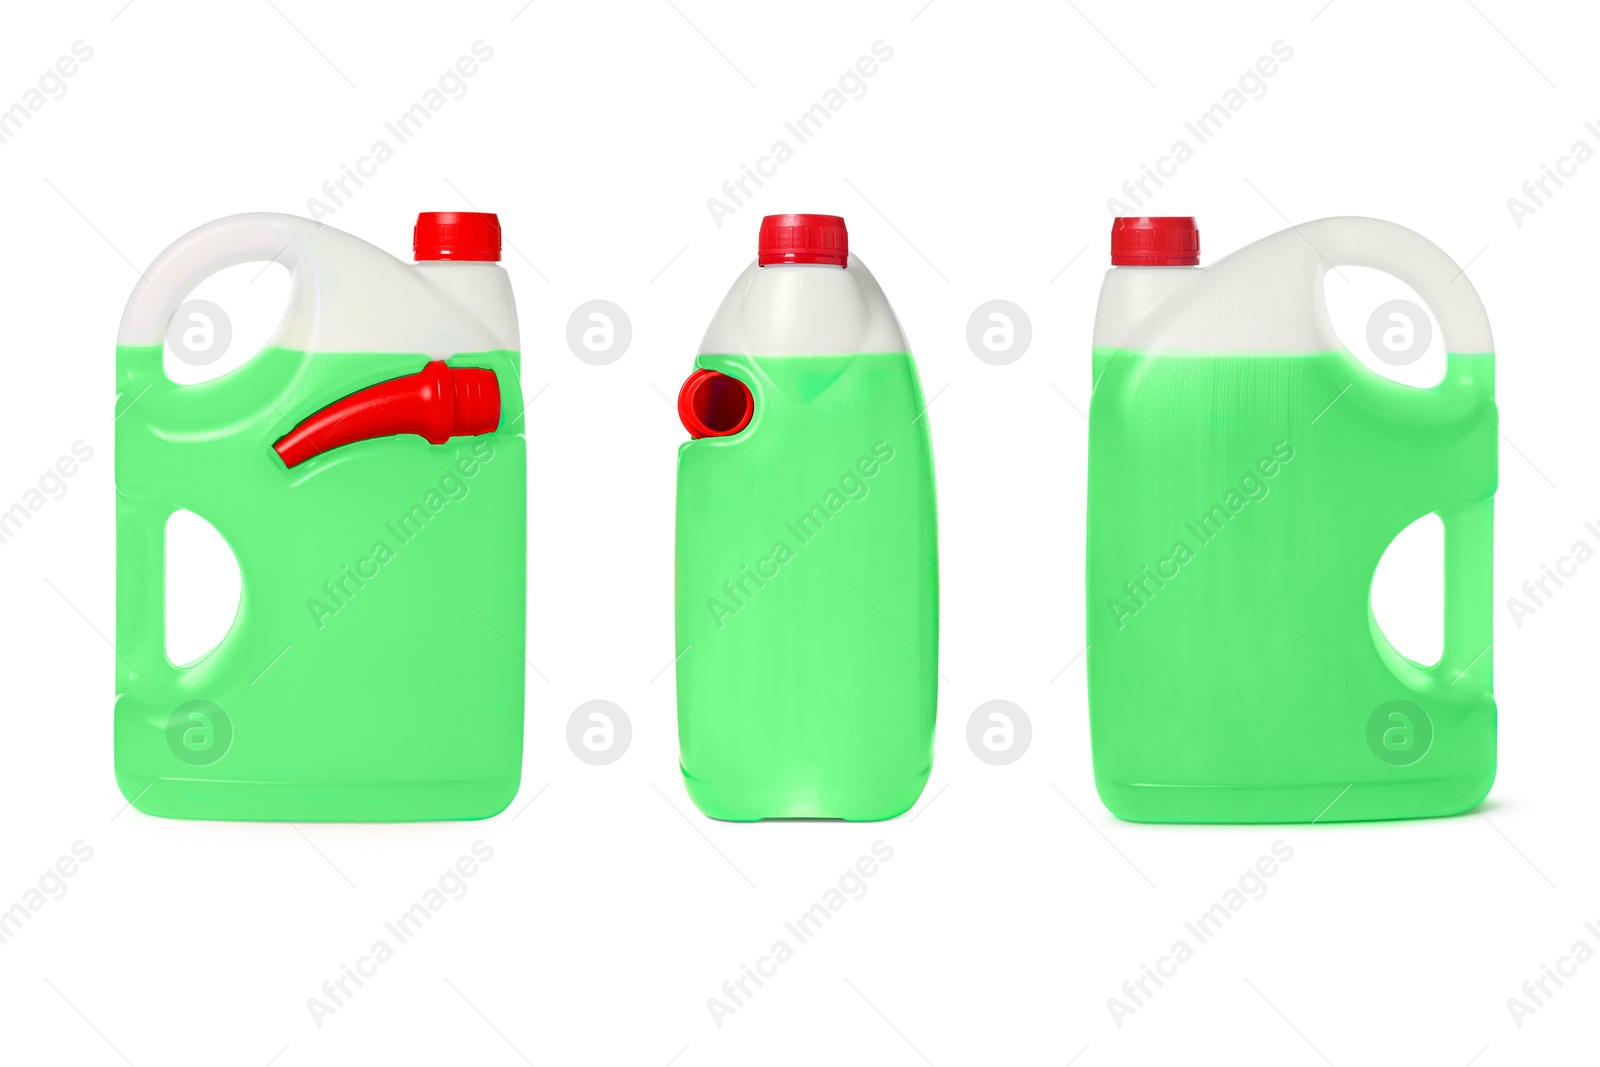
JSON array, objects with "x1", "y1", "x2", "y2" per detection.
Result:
[{"x1": 1373, "y1": 515, "x2": 1445, "y2": 667}]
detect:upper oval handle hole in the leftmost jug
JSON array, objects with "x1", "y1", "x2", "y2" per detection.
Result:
[{"x1": 162, "y1": 262, "x2": 290, "y2": 386}]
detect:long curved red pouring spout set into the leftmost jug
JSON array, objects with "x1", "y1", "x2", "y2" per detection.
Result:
[{"x1": 272, "y1": 360, "x2": 501, "y2": 467}]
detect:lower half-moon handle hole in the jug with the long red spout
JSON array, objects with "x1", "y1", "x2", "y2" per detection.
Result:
[{"x1": 166, "y1": 510, "x2": 240, "y2": 667}]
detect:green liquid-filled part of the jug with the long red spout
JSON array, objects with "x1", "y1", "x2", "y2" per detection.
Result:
[{"x1": 115, "y1": 347, "x2": 526, "y2": 822}]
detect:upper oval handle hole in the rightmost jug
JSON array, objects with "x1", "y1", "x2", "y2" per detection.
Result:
[{"x1": 1323, "y1": 267, "x2": 1445, "y2": 389}]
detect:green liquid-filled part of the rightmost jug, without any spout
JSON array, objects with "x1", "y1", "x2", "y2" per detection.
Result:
[{"x1": 1086, "y1": 350, "x2": 1498, "y2": 822}]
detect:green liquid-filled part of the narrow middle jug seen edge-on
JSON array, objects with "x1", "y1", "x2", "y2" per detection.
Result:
[{"x1": 677, "y1": 354, "x2": 939, "y2": 821}]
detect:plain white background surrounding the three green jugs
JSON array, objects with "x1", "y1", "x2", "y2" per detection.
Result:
[{"x1": 0, "y1": 0, "x2": 1600, "y2": 1067}]
